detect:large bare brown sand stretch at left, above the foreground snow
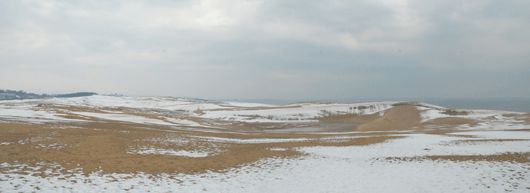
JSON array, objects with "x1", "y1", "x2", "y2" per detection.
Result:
[{"x1": 0, "y1": 122, "x2": 399, "y2": 175}]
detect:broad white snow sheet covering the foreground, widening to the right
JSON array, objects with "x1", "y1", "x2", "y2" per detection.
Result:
[{"x1": 0, "y1": 131, "x2": 530, "y2": 192}]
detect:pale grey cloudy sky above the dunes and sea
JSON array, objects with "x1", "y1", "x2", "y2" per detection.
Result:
[{"x1": 0, "y1": 0, "x2": 530, "y2": 100}]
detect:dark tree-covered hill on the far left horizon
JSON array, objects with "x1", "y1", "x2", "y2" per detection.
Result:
[{"x1": 0, "y1": 89, "x2": 98, "y2": 100}]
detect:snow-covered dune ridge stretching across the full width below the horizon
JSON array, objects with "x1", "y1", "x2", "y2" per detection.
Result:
[{"x1": 0, "y1": 95, "x2": 527, "y2": 130}]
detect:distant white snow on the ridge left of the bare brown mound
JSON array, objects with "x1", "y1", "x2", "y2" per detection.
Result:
[{"x1": 0, "y1": 95, "x2": 397, "y2": 123}]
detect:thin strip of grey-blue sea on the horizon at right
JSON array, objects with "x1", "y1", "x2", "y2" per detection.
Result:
[{"x1": 222, "y1": 98, "x2": 530, "y2": 112}]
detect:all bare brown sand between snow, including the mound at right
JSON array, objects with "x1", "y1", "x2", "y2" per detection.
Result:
[{"x1": 0, "y1": 102, "x2": 530, "y2": 179}]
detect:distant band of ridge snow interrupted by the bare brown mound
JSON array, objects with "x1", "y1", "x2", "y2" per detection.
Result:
[{"x1": 8, "y1": 95, "x2": 521, "y2": 127}]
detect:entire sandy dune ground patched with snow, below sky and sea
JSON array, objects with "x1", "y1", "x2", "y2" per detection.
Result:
[{"x1": 0, "y1": 96, "x2": 530, "y2": 192}]
